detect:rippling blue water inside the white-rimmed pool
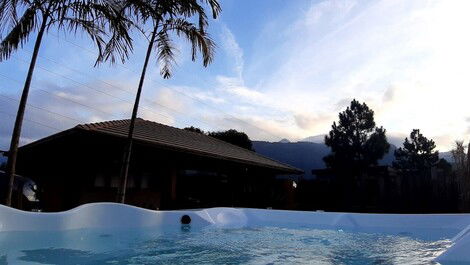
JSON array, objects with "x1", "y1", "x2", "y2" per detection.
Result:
[{"x1": 0, "y1": 226, "x2": 451, "y2": 265}]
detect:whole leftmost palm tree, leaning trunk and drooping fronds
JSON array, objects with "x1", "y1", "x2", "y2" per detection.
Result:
[{"x1": 0, "y1": 0, "x2": 132, "y2": 206}]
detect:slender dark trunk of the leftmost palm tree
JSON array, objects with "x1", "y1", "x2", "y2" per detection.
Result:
[{"x1": 5, "y1": 16, "x2": 47, "y2": 206}]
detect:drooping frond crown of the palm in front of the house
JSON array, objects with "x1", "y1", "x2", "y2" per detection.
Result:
[{"x1": 125, "y1": 0, "x2": 221, "y2": 78}]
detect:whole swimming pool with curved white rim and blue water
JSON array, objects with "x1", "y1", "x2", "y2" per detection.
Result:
[{"x1": 0, "y1": 203, "x2": 470, "y2": 264}]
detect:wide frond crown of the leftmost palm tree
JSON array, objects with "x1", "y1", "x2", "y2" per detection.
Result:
[{"x1": 0, "y1": 0, "x2": 132, "y2": 63}]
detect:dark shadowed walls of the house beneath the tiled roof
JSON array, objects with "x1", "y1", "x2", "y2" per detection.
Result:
[{"x1": 18, "y1": 131, "x2": 282, "y2": 211}]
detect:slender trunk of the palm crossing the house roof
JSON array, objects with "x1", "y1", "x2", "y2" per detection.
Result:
[{"x1": 117, "y1": 24, "x2": 158, "y2": 203}]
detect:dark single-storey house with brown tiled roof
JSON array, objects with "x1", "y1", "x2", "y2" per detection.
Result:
[{"x1": 17, "y1": 119, "x2": 303, "y2": 211}]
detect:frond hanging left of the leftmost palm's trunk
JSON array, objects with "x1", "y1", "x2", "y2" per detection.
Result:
[{"x1": 0, "y1": 7, "x2": 38, "y2": 62}]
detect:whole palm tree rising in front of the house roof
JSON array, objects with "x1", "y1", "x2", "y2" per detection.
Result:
[{"x1": 117, "y1": 0, "x2": 221, "y2": 203}]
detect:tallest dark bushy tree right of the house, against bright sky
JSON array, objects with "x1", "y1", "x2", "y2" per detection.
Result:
[{"x1": 323, "y1": 99, "x2": 390, "y2": 173}]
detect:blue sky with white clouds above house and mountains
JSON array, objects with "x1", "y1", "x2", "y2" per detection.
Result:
[{"x1": 0, "y1": 0, "x2": 470, "y2": 151}]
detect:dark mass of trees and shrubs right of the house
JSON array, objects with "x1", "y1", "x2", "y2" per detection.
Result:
[{"x1": 306, "y1": 100, "x2": 464, "y2": 213}]
